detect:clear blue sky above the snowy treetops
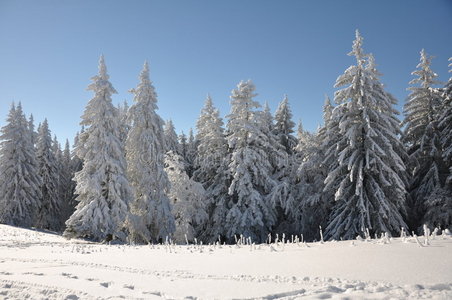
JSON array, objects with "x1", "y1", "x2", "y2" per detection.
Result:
[{"x1": 0, "y1": 0, "x2": 452, "y2": 143}]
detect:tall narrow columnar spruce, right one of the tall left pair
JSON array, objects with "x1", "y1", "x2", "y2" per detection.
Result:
[{"x1": 126, "y1": 62, "x2": 175, "y2": 242}]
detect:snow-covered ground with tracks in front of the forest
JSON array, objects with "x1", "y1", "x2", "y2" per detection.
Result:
[{"x1": 0, "y1": 225, "x2": 452, "y2": 299}]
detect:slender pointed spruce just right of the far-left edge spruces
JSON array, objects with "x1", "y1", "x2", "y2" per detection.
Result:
[{"x1": 35, "y1": 119, "x2": 61, "y2": 231}]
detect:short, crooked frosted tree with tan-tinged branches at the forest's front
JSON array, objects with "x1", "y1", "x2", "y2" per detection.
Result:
[{"x1": 165, "y1": 151, "x2": 208, "y2": 243}]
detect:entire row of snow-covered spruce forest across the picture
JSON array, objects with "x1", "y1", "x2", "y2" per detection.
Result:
[{"x1": 0, "y1": 31, "x2": 452, "y2": 243}]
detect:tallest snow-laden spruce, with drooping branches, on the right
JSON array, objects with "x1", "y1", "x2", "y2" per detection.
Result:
[{"x1": 325, "y1": 31, "x2": 406, "y2": 239}]
